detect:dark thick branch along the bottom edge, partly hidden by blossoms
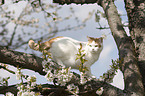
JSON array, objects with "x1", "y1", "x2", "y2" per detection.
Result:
[{"x1": 0, "y1": 78, "x2": 125, "y2": 96}]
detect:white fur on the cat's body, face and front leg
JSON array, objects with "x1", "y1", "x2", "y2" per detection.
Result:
[{"x1": 49, "y1": 37, "x2": 103, "y2": 76}]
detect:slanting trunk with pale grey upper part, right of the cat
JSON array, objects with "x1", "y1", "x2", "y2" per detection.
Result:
[{"x1": 101, "y1": 0, "x2": 144, "y2": 96}]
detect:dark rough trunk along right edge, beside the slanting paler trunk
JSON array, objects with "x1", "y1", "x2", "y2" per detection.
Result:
[{"x1": 125, "y1": 0, "x2": 145, "y2": 88}]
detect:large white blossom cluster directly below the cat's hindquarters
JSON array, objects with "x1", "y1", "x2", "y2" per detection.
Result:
[{"x1": 42, "y1": 60, "x2": 73, "y2": 86}]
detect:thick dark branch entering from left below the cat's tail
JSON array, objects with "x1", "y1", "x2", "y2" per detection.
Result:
[{"x1": 0, "y1": 47, "x2": 45, "y2": 75}]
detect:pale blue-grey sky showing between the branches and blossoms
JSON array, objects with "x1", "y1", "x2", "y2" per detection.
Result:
[{"x1": 0, "y1": 0, "x2": 129, "y2": 94}]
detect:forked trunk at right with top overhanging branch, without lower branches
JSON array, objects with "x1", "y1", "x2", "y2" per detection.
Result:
[{"x1": 55, "y1": 0, "x2": 145, "y2": 96}]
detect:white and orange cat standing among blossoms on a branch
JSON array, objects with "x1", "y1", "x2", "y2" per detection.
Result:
[{"x1": 28, "y1": 37, "x2": 103, "y2": 76}]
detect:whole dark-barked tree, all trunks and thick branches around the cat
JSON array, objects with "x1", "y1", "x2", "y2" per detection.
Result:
[{"x1": 0, "y1": 0, "x2": 145, "y2": 96}]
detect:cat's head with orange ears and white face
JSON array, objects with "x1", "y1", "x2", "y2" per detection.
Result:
[{"x1": 87, "y1": 36, "x2": 103, "y2": 53}]
